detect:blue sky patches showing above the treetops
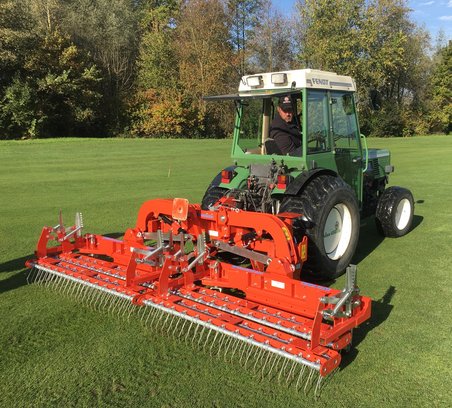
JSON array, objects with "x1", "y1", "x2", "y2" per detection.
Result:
[{"x1": 273, "y1": 0, "x2": 452, "y2": 43}]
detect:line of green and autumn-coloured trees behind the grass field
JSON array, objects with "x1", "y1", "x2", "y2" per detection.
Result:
[{"x1": 0, "y1": 0, "x2": 452, "y2": 139}]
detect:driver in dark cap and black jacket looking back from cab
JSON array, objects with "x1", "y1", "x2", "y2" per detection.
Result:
[{"x1": 270, "y1": 95, "x2": 301, "y2": 156}]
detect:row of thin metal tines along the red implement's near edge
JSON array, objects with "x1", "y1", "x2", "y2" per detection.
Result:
[{"x1": 27, "y1": 266, "x2": 330, "y2": 398}]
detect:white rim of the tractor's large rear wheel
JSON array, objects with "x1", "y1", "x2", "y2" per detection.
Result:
[{"x1": 323, "y1": 204, "x2": 352, "y2": 261}]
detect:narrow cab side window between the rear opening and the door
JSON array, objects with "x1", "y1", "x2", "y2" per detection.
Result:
[{"x1": 307, "y1": 91, "x2": 331, "y2": 154}]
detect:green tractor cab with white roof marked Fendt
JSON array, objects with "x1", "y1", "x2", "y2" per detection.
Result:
[{"x1": 207, "y1": 69, "x2": 367, "y2": 207}]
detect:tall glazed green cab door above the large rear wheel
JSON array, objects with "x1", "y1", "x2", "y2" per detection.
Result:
[{"x1": 329, "y1": 91, "x2": 363, "y2": 202}]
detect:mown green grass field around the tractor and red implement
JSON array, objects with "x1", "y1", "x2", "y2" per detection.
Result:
[{"x1": 0, "y1": 136, "x2": 452, "y2": 407}]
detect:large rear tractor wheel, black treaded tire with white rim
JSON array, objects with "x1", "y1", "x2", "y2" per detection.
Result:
[{"x1": 280, "y1": 175, "x2": 360, "y2": 279}]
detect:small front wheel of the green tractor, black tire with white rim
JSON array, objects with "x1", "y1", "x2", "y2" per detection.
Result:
[{"x1": 375, "y1": 186, "x2": 414, "y2": 238}]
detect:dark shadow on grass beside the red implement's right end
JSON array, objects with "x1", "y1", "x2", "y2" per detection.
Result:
[{"x1": 340, "y1": 286, "x2": 396, "y2": 370}]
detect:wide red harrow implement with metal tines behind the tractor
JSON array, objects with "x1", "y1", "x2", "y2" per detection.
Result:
[{"x1": 26, "y1": 198, "x2": 371, "y2": 393}]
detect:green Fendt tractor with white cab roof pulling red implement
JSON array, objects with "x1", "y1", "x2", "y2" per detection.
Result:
[{"x1": 201, "y1": 69, "x2": 414, "y2": 279}]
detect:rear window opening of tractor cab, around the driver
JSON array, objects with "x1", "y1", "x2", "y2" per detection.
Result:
[{"x1": 236, "y1": 93, "x2": 302, "y2": 155}]
